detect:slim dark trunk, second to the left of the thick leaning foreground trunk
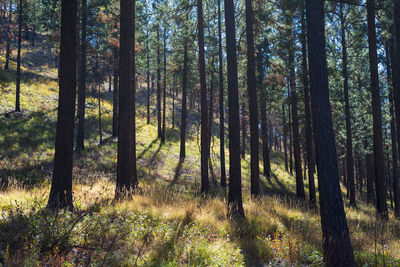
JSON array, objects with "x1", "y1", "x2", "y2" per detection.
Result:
[{"x1": 289, "y1": 34, "x2": 306, "y2": 198}]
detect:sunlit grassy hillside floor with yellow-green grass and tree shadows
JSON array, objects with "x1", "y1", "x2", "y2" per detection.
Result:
[{"x1": 0, "y1": 38, "x2": 400, "y2": 266}]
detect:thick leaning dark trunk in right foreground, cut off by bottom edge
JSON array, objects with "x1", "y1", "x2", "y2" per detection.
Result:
[{"x1": 306, "y1": 0, "x2": 355, "y2": 266}]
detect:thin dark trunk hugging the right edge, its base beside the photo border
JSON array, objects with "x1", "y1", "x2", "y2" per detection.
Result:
[{"x1": 385, "y1": 40, "x2": 400, "y2": 218}]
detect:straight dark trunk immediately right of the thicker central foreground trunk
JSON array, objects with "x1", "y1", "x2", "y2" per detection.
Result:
[{"x1": 245, "y1": 0, "x2": 260, "y2": 196}]
